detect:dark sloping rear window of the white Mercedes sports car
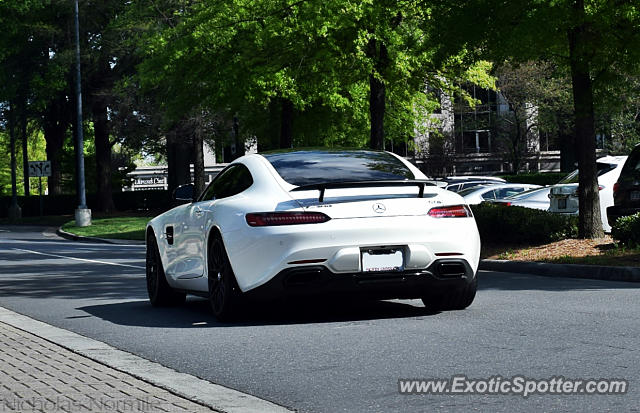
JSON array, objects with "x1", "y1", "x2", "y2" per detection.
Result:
[{"x1": 262, "y1": 150, "x2": 415, "y2": 186}]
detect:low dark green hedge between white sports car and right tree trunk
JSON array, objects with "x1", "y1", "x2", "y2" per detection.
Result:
[{"x1": 471, "y1": 203, "x2": 578, "y2": 244}]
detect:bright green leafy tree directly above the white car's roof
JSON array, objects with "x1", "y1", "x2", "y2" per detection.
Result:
[{"x1": 139, "y1": 0, "x2": 484, "y2": 149}]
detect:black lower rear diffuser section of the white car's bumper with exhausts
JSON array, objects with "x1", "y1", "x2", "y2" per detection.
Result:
[{"x1": 246, "y1": 258, "x2": 475, "y2": 300}]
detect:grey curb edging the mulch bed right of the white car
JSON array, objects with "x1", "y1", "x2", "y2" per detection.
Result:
[{"x1": 479, "y1": 260, "x2": 640, "y2": 282}]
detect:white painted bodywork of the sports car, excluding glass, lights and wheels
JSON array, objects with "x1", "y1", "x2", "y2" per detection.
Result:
[{"x1": 148, "y1": 154, "x2": 480, "y2": 293}]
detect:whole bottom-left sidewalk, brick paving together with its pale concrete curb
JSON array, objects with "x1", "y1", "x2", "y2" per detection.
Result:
[{"x1": 0, "y1": 307, "x2": 292, "y2": 413}]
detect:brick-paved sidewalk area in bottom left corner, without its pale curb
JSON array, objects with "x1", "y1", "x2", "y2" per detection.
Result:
[{"x1": 0, "y1": 322, "x2": 214, "y2": 412}]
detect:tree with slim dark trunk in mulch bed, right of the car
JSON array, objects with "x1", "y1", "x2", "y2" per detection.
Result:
[{"x1": 433, "y1": 0, "x2": 640, "y2": 238}]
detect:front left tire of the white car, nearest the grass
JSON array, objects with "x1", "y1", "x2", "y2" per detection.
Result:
[{"x1": 146, "y1": 234, "x2": 187, "y2": 307}]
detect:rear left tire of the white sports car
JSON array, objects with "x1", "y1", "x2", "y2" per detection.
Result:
[{"x1": 207, "y1": 233, "x2": 242, "y2": 321}]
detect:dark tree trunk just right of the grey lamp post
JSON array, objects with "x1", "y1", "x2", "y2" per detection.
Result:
[{"x1": 91, "y1": 94, "x2": 116, "y2": 212}]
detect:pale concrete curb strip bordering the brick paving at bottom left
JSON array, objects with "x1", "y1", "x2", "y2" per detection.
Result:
[{"x1": 0, "y1": 306, "x2": 294, "y2": 413}]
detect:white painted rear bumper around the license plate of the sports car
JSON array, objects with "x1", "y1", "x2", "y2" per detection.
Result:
[{"x1": 223, "y1": 215, "x2": 480, "y2": 292}]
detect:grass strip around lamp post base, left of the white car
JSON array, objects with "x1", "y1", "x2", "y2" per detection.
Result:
[{"x1": 62, "y1": 216, "x2": 153, "y2": 241}]
